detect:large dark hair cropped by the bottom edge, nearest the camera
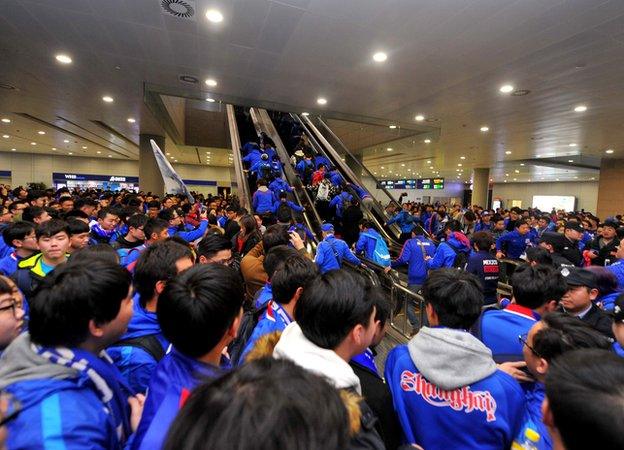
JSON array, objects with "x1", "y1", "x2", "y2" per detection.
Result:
[{"x1": 163, "y1": 358, "x2": 349, "y2": 450}]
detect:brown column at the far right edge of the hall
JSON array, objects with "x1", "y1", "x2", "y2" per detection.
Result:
[{"x1": 596, "y1": 158, "x2": 624, "y2": 220}]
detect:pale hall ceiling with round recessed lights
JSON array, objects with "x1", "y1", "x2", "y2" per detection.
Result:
[{"x1": 0, "y1": 0, "x2": 624, "y2": 182}]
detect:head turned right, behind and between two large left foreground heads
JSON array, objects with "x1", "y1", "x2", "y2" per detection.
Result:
[{"x1": 134, "y1": 240, "x2": 193, "y2": 307}]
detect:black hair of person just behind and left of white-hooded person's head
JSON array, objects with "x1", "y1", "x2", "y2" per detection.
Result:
[{"x1": 267, "y1": 253, "x2": 318, "y2": 305}]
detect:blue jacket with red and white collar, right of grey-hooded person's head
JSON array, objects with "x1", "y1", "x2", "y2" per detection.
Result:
[{"x1": 475, "y1": 303, "x2": 540, "y2": 362}]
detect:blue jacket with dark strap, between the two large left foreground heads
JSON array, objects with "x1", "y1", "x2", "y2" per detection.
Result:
[{"x1": 106, "y1": 294, "x2": 169, "y2": 393}]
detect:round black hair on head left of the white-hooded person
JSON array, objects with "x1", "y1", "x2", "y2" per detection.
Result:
[{"x1": 156, "y1": 264, "x2": 244, "y2": 358}]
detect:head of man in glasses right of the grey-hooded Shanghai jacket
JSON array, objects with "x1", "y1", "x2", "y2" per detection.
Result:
[{"x1": 519, "y1": 312, "x2": 611, "y2": 382}]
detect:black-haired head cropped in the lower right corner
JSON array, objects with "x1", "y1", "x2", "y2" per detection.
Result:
[{"x1": 542, "y1": 349, "x2": 624, "y2": 450}]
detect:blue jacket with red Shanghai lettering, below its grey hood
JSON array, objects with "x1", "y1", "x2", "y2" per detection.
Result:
[{"x1": 385, "y1": 332, "x2": 524, "y2": 450}]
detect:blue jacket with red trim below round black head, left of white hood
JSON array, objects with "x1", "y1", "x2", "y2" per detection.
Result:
[{"x1": 131, "y1": 348, "x2": 221, "y2": 450}]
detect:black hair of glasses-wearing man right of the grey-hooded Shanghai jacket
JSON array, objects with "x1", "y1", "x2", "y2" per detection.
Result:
[{"x1": 532, "y1": 312, "x2": 611, "y2": 361}]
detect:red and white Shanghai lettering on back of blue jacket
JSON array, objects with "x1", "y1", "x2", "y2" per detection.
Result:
[{"x1": 401, "y1": 370, "x2": 496, "y2": 422}]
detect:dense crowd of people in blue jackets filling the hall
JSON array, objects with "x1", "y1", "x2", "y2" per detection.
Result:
[{"x1": 0, "y1": 163, "x2": 624, "y2": 450}]
